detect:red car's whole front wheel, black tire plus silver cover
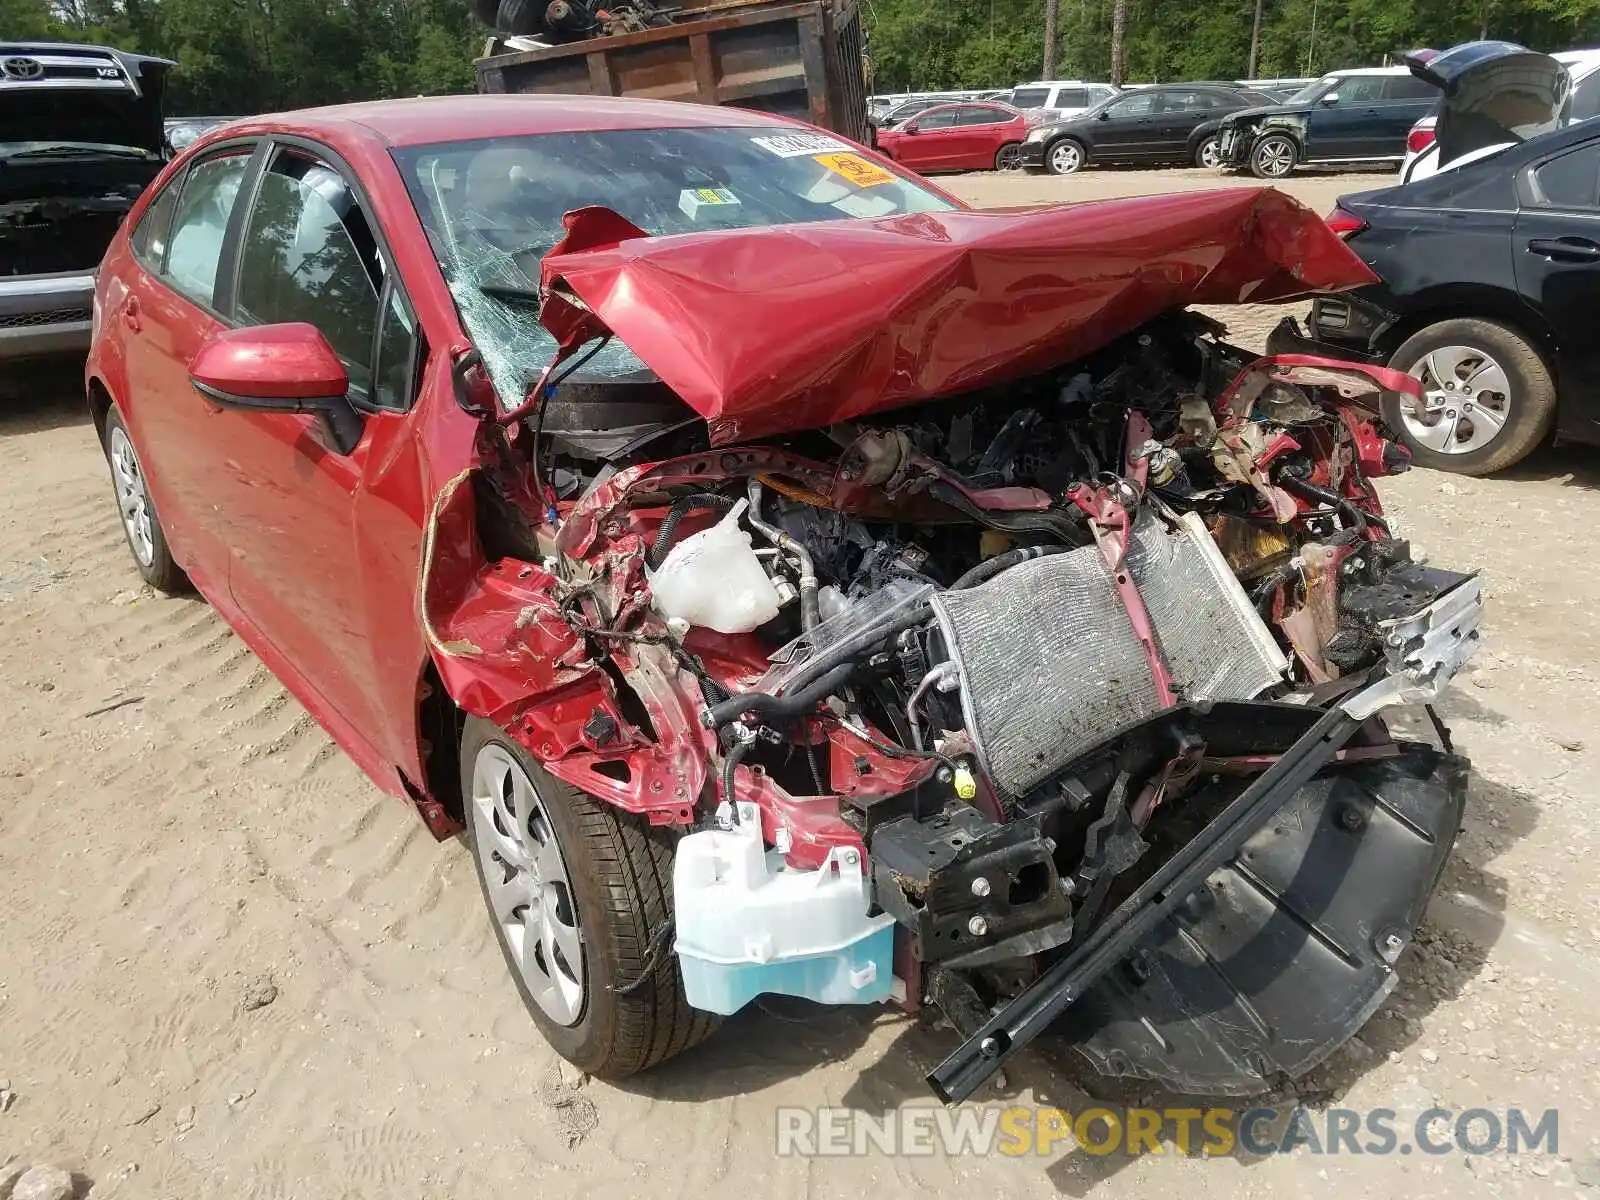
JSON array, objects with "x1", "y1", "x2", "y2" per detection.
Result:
[{"x1": 461, "y1": 717, "x2": 718, "y2": 1080}]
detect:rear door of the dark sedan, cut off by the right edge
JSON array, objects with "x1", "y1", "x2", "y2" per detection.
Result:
[{"x1": 1515, "y1": 138, "x2": 1600, "y2": 438}]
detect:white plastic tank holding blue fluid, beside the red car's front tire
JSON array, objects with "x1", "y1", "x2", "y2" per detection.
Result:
[{"x1": 672, "y1": 803, "x2": 894, "y2": 1016}]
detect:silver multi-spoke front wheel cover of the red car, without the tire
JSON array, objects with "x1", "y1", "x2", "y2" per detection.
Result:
[{"x1": 470, "y1": 742, "x2": 586, "y2": 1026}]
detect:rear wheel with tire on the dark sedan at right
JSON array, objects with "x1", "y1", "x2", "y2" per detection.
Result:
[{"x1": 1384, "y1": 317, "x2": 1555, "y2": 475}]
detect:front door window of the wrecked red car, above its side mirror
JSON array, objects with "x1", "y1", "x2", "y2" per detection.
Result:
[{"x1": 235, "y1": 150, "x2": 382, "y2": 395}]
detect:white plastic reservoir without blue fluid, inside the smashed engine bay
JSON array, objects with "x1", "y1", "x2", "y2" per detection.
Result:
[{"x1": 645, "y1": 501, "x2": 781, "y2": 634}]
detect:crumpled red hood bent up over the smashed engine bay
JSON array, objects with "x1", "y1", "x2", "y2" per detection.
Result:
[{"x1": 541, "y1": 189, "x2": 1376, "y2": 445}]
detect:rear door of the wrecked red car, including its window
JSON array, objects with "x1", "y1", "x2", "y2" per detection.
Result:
[{"x1": 116, "y1": 142, "x2": 256, "y2": 595}]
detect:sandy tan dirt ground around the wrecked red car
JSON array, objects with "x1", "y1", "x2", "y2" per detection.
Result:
[{"x1": 0, "y1": 171, "x2": 1600, "y2": 1200}]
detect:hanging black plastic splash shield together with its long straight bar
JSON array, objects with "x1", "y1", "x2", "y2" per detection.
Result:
[{"x1": 928, "y1": 706, "x2": 1467, "y2": 1102}]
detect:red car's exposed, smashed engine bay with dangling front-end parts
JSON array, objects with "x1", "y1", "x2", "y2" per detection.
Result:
[{"x1": 424, "y1": 312, "x2": 1480, "y2": 1099}]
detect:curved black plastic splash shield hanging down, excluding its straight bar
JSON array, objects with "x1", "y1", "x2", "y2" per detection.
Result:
[{"x1": 1053, "y1": 746, "x2": 1467, "y2": 1096}]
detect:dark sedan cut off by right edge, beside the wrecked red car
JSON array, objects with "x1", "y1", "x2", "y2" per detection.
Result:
[{"x1": 1269, "y1": 110, "x2": 1600, "y2": 475}]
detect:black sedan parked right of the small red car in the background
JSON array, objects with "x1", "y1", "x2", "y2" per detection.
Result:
[{"x1": 1022, "y1": 83, "x2": 1267, "y2": 174}]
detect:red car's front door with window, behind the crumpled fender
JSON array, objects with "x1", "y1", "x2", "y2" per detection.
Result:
[{"x1": 203, "y1": 147, "x2": 414, "y2": 762}]
